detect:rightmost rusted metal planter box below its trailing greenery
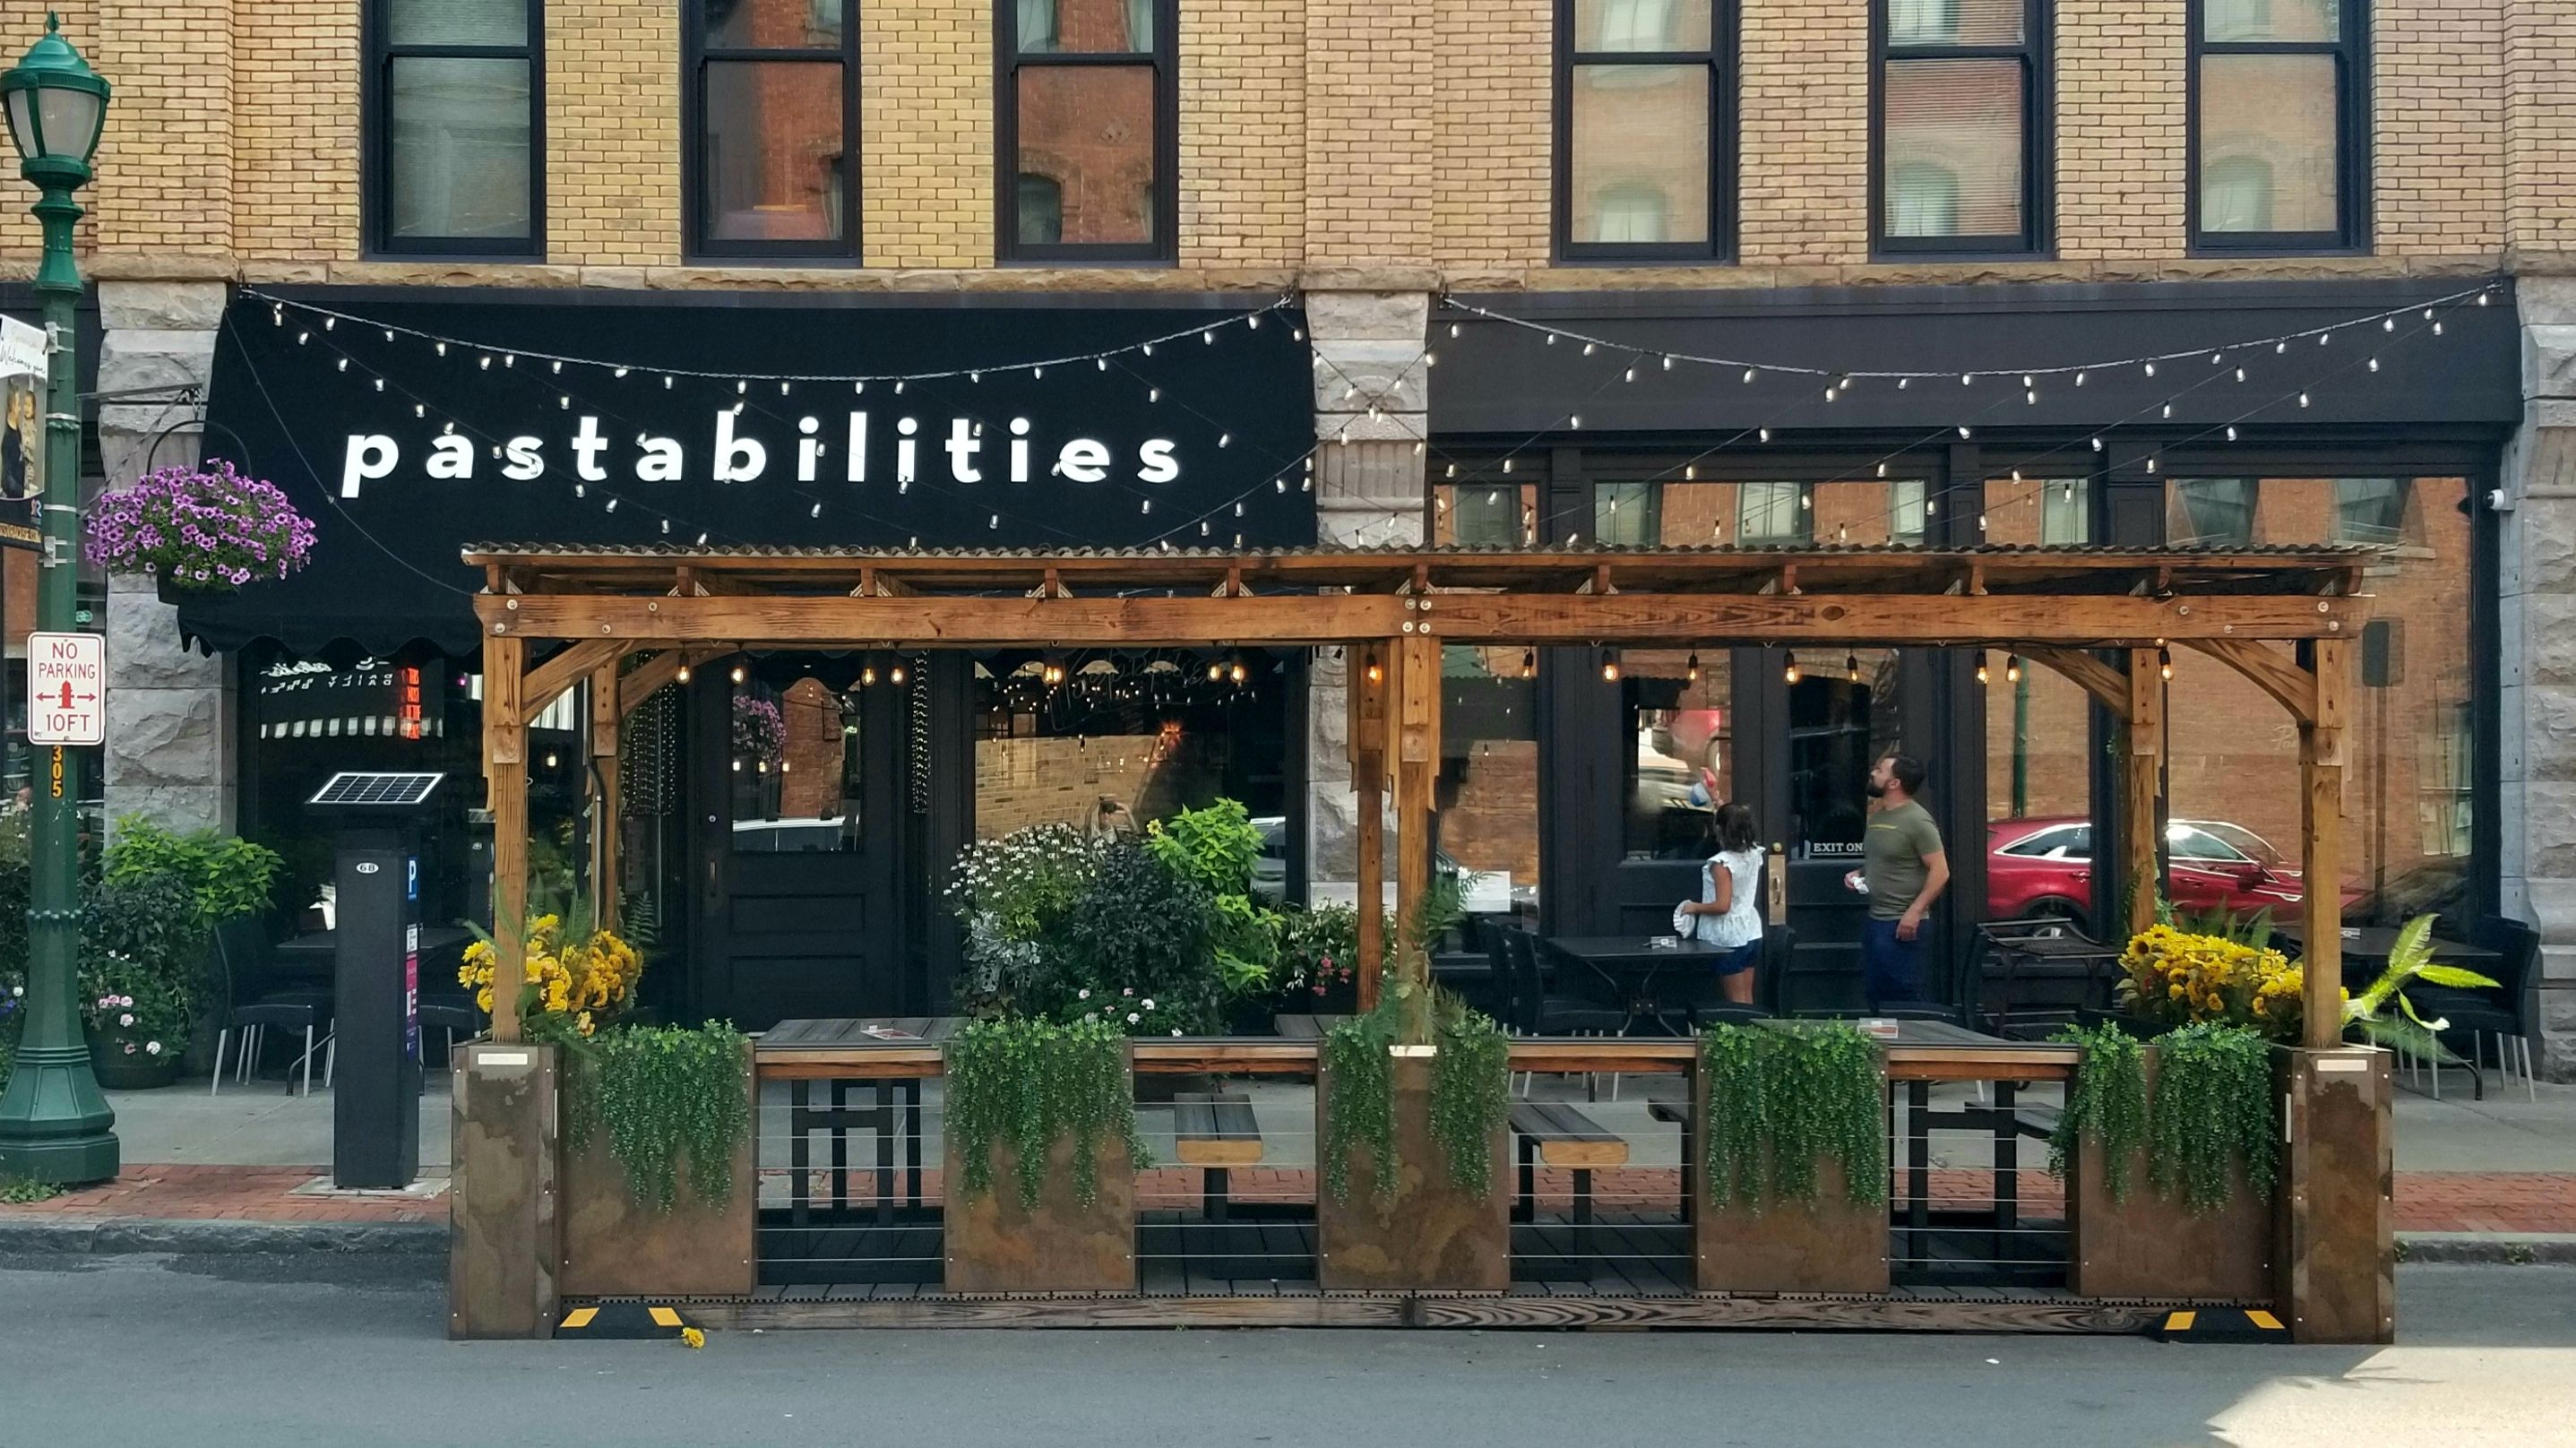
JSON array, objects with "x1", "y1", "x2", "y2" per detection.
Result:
[{"x1": 2066, "y1": 1046, "x2": 2272, "y2": 1304}]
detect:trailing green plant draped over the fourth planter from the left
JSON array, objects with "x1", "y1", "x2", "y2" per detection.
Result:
[{"x1": 1701, "y1": 1021, "x2": 1888, "y2": 1211}]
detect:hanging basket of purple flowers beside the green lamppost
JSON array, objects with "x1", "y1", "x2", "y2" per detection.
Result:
[{"x1": 85, "y1": 459, "x2": 314, "y2": 595}]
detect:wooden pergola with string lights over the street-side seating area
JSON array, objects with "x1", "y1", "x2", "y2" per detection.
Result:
[{"x1": 464, "y1": 544, "x2": 2378, "y2": 1048}]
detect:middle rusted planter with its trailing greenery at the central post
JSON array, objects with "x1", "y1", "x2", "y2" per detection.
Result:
[{"x1": 1316, "y1": 879, "x2": 1512, "y2": 1291}]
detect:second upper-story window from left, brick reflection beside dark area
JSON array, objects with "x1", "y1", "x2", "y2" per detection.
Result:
[{"x1": 680, "y1": 0, "x2": 857, "y2": 260}]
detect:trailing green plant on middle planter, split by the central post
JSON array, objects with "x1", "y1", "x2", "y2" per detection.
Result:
[{"x1": 1322, "y1": 984, "x2": 1512, "y2": 1203}]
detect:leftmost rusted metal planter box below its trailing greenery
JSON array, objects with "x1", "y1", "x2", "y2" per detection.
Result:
[{"x1": 556, "y1": 1046, "x2": 760, "y2": 1296}]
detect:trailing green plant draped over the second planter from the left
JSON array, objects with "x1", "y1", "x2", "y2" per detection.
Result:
[{"x1": 945, "y1": 1018, "x2": 1151, "y2": 1209}]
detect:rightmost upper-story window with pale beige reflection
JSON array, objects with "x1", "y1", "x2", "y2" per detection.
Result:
[{"x1": 2193, "y1": 0, "x2": 2370, "y2": 250}]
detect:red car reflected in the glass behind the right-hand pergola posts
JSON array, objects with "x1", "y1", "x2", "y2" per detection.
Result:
[{"x1": 1986, "y1": 819, "x2": 2305, "y2": 920}]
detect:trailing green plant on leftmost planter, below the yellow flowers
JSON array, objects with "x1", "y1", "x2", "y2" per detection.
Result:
[{"x1": 564, "y1": 1021, "x2": 753, "y2": 1211}]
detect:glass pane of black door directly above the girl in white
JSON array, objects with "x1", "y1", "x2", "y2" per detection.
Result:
[{"x1": 1602, "y1": 650, "x2": 1736, "y2": 860}]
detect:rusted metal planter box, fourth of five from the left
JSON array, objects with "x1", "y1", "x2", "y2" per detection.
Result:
[{"x1": 1684, "y1": 1072, "x2": 1888, "y2": 1296}]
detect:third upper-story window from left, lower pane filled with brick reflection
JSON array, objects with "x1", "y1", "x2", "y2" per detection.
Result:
[{"x1": 995, "y1": 0, "x2": 1180, "y2": 260}]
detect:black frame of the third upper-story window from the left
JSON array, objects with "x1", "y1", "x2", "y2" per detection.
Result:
[{"x1": 992, "y1": 0, "x2": 1180, "y2": 265}]
